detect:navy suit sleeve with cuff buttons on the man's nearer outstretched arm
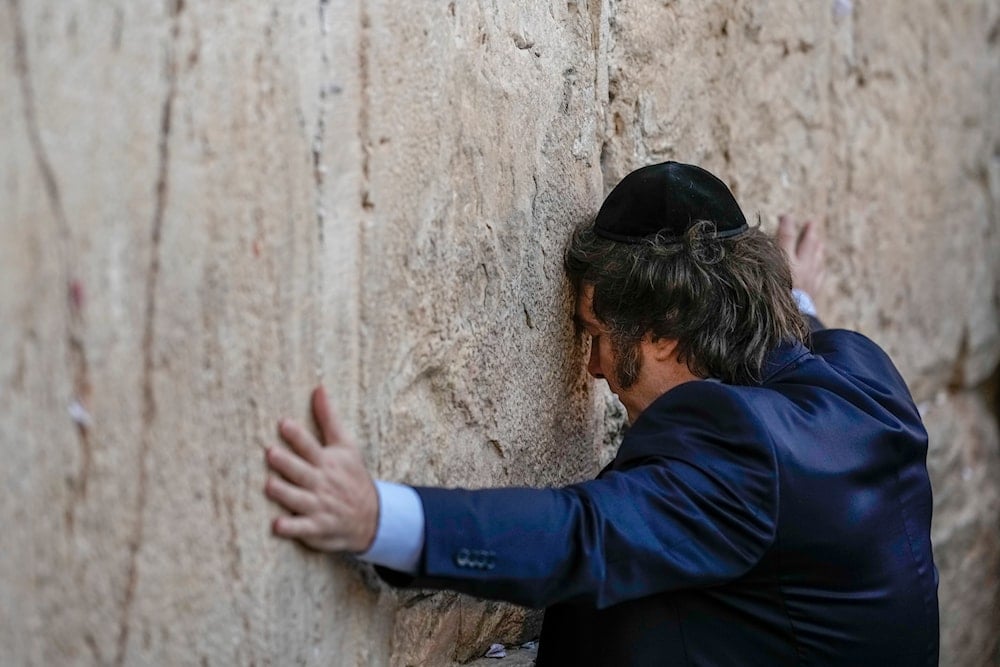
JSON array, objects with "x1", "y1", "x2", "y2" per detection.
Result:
[{"x1": 383, "y1": 386, "x2": 776, "y2": 608}]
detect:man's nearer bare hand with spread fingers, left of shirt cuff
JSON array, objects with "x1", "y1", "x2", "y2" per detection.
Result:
[{"x1": 264, "y1": 387, "x2": 379, "y2": 553}]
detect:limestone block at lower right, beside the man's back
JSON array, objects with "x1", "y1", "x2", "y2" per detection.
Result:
[{"x1": 920, "y1": 387, "x2": 1000, "y2": 667}]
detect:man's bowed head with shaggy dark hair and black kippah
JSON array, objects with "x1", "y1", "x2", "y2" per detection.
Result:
[{"x1": 566, "y1": 162, "x2": 808, "y2": 407}]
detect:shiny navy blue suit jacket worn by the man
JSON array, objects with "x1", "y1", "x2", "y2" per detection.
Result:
[{"x1": 383, "y1": 330, "x2": 938, "y2": 666}]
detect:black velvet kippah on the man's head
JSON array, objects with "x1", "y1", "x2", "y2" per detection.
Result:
[{"x1": 594, "y1": 162, "x2": 747, "y2": 243}]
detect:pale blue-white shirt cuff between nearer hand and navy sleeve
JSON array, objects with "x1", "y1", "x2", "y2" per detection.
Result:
[{"x1": 357, "y1": 480, "x2": 424, "y2": 574}]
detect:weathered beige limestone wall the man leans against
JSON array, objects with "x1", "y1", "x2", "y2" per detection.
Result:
[{"x1": 0, "y1": 0, "x2": 1000, "y2": 665}]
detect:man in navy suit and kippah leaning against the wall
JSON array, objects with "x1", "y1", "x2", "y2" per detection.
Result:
[{"x1": 266, "y1": 162, "x2": 938, "y2": 666}]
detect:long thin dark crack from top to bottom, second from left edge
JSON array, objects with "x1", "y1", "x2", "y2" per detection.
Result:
[{"x1": 114, "y1": 0, "x2": 184, "y2": 666}]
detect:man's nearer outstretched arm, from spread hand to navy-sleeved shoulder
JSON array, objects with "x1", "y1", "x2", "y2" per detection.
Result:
[{"x1": 267, "y1": 383, "x2": 776, "y2": 608}]
